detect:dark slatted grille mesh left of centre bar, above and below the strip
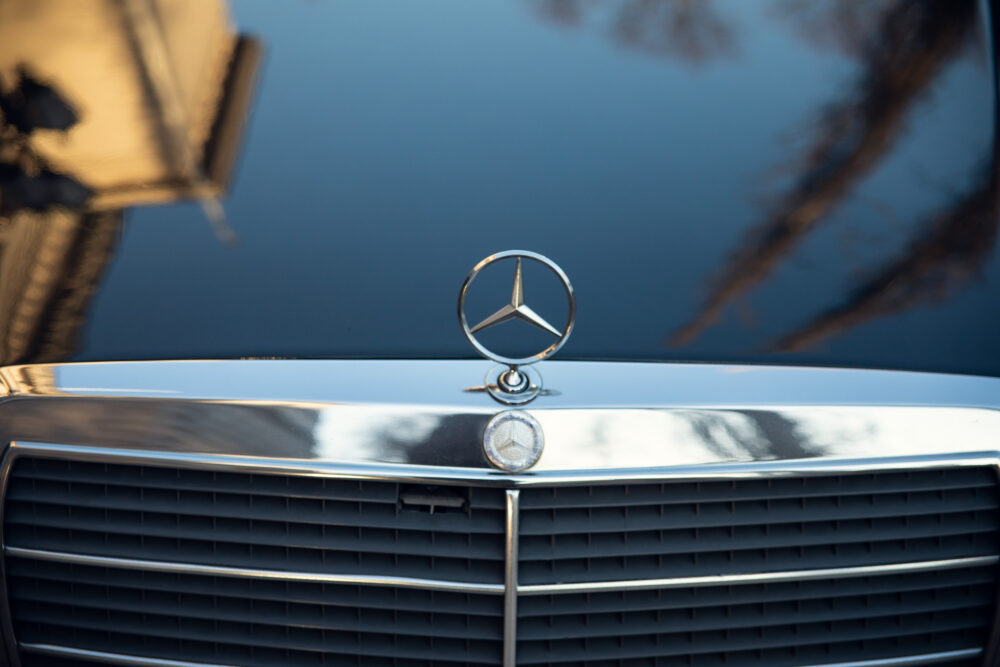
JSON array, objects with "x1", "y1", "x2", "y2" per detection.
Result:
[{"x1": 5, "y1": 458, "x2": 505, "y2": 665}]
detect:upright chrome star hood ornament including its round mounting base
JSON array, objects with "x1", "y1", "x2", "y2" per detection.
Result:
[{"x1": 458, "y1": 250, "x2": 576, "y2": 405}]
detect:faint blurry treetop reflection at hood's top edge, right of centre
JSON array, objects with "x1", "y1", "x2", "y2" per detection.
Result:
[{"x1": 535, "y1": 0, "x2": 734, "y2": 64}]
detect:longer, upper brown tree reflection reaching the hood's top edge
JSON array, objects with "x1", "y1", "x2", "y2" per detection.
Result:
[{"x1": 671, "y1": 0, "x2": 976, "y2": 345}]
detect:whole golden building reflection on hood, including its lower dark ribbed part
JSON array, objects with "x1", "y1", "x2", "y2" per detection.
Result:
[{"x1": 0, "y1": 0, "x2": 260, "y2": 364}]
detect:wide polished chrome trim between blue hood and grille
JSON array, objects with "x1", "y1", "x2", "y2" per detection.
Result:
[{"x1": 0, "y1": 361, "x2": 1000, "y2": 474}]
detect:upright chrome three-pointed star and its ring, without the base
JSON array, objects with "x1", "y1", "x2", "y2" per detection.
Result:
[{"x1": 458, "y1": 250, "x2": 576, "y2": 368}]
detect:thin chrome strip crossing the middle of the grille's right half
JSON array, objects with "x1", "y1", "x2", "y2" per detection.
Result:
[{"x1": 517, "y1": 556, "x2": 1000, "y2": 595}]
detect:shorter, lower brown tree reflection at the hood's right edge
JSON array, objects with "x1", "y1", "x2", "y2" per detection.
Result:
[{"x1": 776, "y1": 173, "x2": 998, "y2": 352}]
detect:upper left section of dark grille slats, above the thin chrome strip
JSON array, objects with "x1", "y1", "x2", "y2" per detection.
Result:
[{"x1": 4, "y1": 458, "x2": 505, "y2": 584}]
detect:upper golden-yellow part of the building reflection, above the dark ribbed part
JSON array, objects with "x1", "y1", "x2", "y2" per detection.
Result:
[{"x1": 0, "y1": 0, "x2": 260, "y2": 209}]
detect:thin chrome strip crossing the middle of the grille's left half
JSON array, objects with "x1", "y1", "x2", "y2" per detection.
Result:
[{"x1": 4, "y1": 546, "x2": 504, "y2": 595}]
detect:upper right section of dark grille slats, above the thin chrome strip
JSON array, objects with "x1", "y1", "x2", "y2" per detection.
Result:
[{"x1": 520, "y1": 468, "x2": 1000, "y2": 584}]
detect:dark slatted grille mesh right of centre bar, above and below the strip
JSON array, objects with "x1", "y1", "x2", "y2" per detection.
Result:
[{"x1": 517, "y1": 468, "x2": 1000, "y2": 667}]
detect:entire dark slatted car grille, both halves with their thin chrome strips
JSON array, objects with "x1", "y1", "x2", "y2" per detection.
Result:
[{"x1": 4, "y1": 457, "x2": 1000, "y2": 667}]
